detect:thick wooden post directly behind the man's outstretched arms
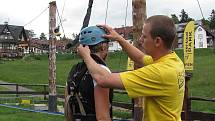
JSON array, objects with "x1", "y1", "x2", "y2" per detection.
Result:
[{"x1": 132, "y1": 0, "x2": 146, "y2": 121}]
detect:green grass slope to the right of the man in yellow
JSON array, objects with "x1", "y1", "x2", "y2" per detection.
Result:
[{"x1": 177, "y1": 49, "x2": 215, "y2": 113}]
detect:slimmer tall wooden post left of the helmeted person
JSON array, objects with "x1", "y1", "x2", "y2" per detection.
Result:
[{"x1": 48, "y1": 1, "x2": 57, "y2": 112}]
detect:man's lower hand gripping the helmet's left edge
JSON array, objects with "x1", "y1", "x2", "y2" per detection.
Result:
[{"x1": 77, "y1": 44, "x2": 90, "y2": 59}]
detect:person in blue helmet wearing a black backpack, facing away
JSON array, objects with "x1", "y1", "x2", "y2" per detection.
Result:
[{"x1": 65, "y1": 26, "x2": 113, "y2": 121}]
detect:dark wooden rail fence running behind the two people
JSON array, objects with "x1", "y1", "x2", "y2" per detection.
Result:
[{"x1": 0, "y1": 84, "x2": 215, "y2": 121}]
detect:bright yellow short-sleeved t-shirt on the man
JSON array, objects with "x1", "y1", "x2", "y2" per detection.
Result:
[{"x1": 120, "y1": 52, "x2": 185, "y2": 121}]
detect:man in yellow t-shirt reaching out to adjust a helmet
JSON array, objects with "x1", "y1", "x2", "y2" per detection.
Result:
[{"x1": 77, "y1": 15, "x2": 185, "y2": 121}]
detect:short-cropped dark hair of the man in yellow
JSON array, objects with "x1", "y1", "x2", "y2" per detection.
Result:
[{"x1": 145, "y1": 15, "x2": 176, "y2": 49}]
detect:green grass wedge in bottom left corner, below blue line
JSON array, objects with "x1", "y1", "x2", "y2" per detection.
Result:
[{"x1": 0, "y1": 107, "x2": 65, "y2": 121}]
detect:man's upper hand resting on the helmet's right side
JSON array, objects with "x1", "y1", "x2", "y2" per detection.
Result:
[{"x1": 97, "y1": 25, "x2": 124, "y2": 42}]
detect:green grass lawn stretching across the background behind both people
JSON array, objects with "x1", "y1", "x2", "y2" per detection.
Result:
[{"x1": 0, "y1": 49, "x2": 215, "y2": 113}]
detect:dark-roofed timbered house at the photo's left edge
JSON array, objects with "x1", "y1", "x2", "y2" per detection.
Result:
[{"x1": 0, "y1": 22, "x2": 28, "y2": 57}]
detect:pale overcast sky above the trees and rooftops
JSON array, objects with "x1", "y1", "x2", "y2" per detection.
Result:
[{"x1": 0, "y1": 0, "x2": 215, "y2": 37}]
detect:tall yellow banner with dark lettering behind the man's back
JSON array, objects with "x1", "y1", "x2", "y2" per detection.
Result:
[{"x1": 183, "y1": 21, "x2": 195, "y2": 70}]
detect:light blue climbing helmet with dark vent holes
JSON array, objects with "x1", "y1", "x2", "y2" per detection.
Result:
[{"x1": 79, "y1": 26, "x2": 109, "y2": 45}]
